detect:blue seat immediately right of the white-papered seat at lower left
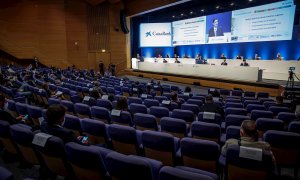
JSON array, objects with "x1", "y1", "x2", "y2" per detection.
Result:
[{"x1": 65, "y1": 142, "x2": 106, "y2": 179}]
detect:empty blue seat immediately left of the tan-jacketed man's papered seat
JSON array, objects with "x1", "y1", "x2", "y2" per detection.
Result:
[{"x1": 180, "y1": 137, "x2": 220, "y2": 173}]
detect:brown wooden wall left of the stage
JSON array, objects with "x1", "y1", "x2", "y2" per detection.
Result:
[{"x1": 0, "y1": 0, "x2": 127, "y2": 71}]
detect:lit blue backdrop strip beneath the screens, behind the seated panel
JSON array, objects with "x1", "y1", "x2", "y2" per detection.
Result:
[{"x1": 141, "y1": 25, "x2": 300, "y2": 60}]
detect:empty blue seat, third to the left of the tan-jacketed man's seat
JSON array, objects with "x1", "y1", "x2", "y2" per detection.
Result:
[{"x1": 108, "y1": 124, "x2": 138, "y2": 155}]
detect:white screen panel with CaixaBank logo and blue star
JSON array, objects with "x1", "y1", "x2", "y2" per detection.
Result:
[{"x1": 140, "y1": 23, "x2": 172, "y2": 47}]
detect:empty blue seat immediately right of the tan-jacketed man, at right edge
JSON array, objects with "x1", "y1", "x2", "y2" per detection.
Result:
[{"x1": 263, "y1": 130, "x2": 300, "y2": 166}]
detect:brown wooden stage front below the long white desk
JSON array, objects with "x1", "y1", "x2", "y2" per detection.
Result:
[{"x1": 119, "y1": 69, "x2": 300, "y2": 96}]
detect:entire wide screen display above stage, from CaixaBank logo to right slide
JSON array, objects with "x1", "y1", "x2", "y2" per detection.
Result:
[{"x1": 140, "y1": 0, "x2": 296, "y2": 47}]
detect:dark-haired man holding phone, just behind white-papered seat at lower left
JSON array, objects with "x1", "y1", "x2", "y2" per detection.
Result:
[{"x1": 41, "y1": 105, "x2": 84, "y2": 143}]
